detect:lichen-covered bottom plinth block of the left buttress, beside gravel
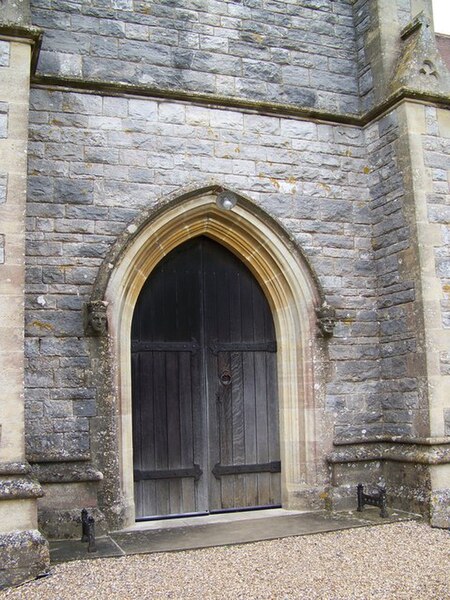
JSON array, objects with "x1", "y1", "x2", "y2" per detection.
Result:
[{"x1": 0, "y1": 529, "x2": 50, "y2": 589}]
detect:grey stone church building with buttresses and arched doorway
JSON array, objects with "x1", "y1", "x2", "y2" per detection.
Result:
[{"x1": 0, "y1": 0, "x2": 450, "y2": 588}]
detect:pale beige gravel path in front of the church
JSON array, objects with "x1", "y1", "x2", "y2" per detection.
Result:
[{"x1": 0, "y1": 522, "x2": 450, "y2": 600}]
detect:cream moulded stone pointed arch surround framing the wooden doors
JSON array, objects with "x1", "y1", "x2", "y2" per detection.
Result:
[{"x1": 101, "y1": 186, "x2": 324, "y2": 526}]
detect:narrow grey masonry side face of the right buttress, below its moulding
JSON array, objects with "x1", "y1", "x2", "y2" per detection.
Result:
[{"x1": 365, "y1": 106, "x2": 425, "y2": 435}]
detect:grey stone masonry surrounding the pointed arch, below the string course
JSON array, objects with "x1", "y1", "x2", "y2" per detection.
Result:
[{"x1": 26, "y1": 89, "x2": 376, "y2": 460}]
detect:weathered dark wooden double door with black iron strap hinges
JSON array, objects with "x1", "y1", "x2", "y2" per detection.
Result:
[{"x1": 131, "y1": 237, "x2": 280, "y2": 519}]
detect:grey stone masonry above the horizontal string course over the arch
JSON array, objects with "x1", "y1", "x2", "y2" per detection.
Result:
[{"x1": 31, "y1": 0, "x2": 359, "y2": 113}]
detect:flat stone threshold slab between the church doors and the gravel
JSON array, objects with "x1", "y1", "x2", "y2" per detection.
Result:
[{"x1": 50, "y1": 507, "x2": 420, "y2": 564}]
